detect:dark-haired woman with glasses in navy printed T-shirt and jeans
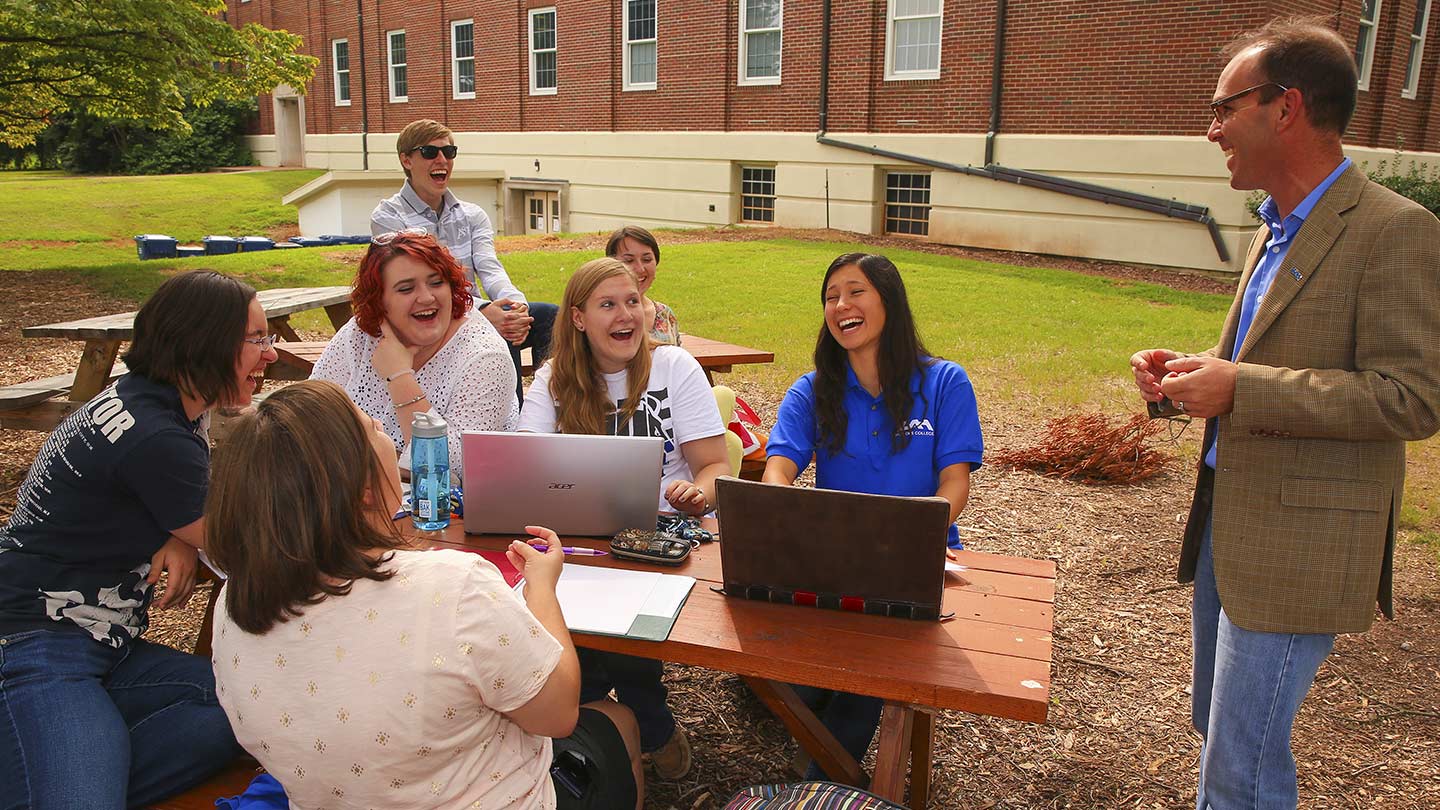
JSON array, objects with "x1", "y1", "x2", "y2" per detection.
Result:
[{"x1": 0, "y1": 271, "x2": 275, "y2": 810}]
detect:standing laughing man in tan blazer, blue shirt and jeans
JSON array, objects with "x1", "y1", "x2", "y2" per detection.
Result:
[{"x1": 1130, "y1": 14, "x2": 1440, "y2": 810}]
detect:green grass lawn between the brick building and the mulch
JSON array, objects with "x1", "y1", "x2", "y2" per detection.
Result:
[{"x1": 0, "y1": 172, "x2": 1440, "y2": 552}]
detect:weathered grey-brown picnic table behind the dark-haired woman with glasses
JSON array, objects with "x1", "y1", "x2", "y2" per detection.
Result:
[{"x1": 0, "y1": 287, "x2": 350, "y2": 431}]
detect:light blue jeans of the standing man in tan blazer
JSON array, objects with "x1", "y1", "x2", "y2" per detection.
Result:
[{"x1": 1191, "y1": 515, "x2": 1335, "y2": 810}]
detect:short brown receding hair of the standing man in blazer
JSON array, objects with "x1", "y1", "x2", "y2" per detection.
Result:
[{"x1": 1221, "y1": 16, "x2": 1358, "y2": 135}]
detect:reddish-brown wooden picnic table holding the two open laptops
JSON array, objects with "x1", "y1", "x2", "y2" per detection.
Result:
[{"x1": 168, "y1": 517, "x2": 1056, "y2": 810}]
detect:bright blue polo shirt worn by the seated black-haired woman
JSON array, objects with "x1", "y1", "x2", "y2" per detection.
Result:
[{"x1": 766, "y1": 360, "x2": 985, "y2": 548}]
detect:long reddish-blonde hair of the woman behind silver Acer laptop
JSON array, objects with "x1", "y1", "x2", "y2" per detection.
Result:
[{"x1": 547, "y1": 258, "x2": 654, "y2": 434}]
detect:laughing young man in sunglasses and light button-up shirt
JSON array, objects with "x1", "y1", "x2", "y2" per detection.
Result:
[{"x1": 370, "y1": 118, "x2": 557, "y2": 399}]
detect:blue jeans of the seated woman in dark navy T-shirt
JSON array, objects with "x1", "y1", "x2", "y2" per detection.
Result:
[{"x1": 0, "y1": 630, "x2": 240, "y2": 810}]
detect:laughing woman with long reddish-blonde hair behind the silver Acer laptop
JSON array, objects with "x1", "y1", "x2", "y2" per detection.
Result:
[{"x1": 520, "y1": 258, "x2": 730, "y2": 778}]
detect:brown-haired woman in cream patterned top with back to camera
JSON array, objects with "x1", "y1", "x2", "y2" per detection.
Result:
[{"x1": 206, "y1": 380, "x2": 641, "y2": 810}]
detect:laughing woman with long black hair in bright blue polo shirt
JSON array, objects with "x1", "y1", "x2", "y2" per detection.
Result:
[{"x1": 765, "y1": 254, "x2": 985, "y2": 778}]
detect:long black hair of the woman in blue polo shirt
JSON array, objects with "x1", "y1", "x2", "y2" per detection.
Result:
[{"x1": 815, "y1": 254, "x2": 935, "y2": 453}]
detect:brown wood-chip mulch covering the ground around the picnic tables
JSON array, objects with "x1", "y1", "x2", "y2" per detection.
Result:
[{"x1": 0, "y1": 236, "x2": 1440, "y2": 810}]
